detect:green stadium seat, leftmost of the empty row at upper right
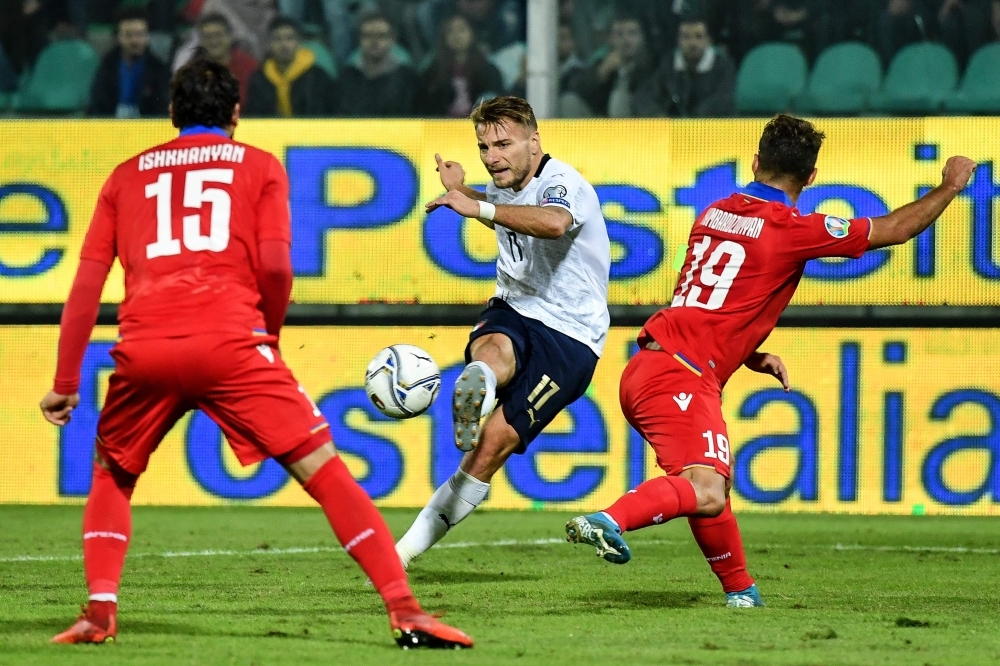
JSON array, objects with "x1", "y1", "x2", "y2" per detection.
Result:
[{"x1": 736, "y1": 43, "x2": 808, "y2": 115}]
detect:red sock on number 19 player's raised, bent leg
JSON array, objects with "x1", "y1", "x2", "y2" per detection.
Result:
[{"x1": 604, "y1": 476, "x2": 698, "y2": 532}]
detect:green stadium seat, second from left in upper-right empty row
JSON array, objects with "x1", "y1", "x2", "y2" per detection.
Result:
[{"x1": 795, "y1": 42, "x2": 882, "y2": 115}]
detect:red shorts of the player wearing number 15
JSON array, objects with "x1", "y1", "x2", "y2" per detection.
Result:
[{"x1": 97, "y1": 333, "x2": 330, "y2": 474}]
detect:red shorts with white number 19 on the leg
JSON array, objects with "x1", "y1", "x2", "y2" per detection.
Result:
[{"x1": 619, "y1": 349, "x2": 730, "y2": 479}]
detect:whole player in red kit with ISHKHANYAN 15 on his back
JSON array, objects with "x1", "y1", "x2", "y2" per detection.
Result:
[{"x1": 41, "y1": 59, "x2": 472, "y2": 647}]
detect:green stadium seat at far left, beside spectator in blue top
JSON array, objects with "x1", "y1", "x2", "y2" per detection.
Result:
[{"x1": 15, "y1": 40, "x2": 97, "y2": 113}]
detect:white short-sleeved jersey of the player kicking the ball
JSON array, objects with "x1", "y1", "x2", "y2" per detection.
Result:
[{"x1": 486, "y1": 155, "x2": 611, "y2": 356}]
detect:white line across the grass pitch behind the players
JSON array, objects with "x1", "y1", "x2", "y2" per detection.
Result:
[{"x1": 0, "y1": 538, "x2": 1000, "y2": 563}]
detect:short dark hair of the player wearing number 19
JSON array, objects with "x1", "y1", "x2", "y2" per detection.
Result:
[{"x1": 757, "y1": 114, "x2": 826, "y2": 185}]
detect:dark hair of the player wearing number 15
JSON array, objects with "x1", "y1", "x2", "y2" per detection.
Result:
[{"x1": 170, "y1": 58, "x2": 240, "y2": 129}]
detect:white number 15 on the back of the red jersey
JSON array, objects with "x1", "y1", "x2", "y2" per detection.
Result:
[{"x1": 146, "y1": 169, "x2": 233, "y2": 259}]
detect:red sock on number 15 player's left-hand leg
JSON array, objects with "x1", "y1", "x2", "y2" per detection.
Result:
[{"x1": 83, "y1": 462, "x2": 135, "y2": 628}]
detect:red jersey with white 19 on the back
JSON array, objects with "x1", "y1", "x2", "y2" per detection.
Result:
[{"x1": 639, "y1": 182, "x2": 871, "y2": 385}]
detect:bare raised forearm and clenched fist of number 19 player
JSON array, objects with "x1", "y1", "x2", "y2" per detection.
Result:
[{"x1": 868, "y1": 156, "x2": 976, "y2": 250}]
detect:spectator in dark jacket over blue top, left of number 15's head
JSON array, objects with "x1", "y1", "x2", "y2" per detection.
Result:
[{"x1": 87, "y1": 8, "x2": 170, "y2": 118}]
